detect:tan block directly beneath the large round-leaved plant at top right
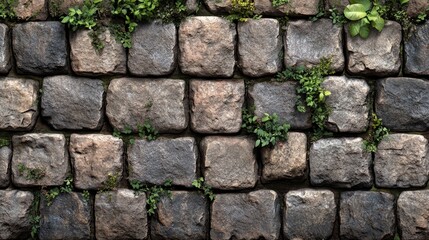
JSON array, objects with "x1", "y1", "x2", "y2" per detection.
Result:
[{"x1": 345, "y1": 21, "x2": 402, "y2": 76}]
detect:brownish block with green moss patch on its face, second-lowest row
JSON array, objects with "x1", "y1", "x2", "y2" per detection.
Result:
[{"x1": 12, "y1": 133, "x2": 70, "y2": 187}]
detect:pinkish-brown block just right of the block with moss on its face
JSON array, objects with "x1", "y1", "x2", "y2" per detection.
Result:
[{"x1": 69, "y1": 134, "x2": 124, "y2": 189}]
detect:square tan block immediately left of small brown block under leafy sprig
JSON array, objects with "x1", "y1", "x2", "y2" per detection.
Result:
[{"x1": 201, "y1": 136, "x2": 258, "y2": 190}]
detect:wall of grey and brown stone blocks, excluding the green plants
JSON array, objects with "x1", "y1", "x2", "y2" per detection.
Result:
[{"x1": 0, "y1": 0, "x2": 429, "y2": 239}]
